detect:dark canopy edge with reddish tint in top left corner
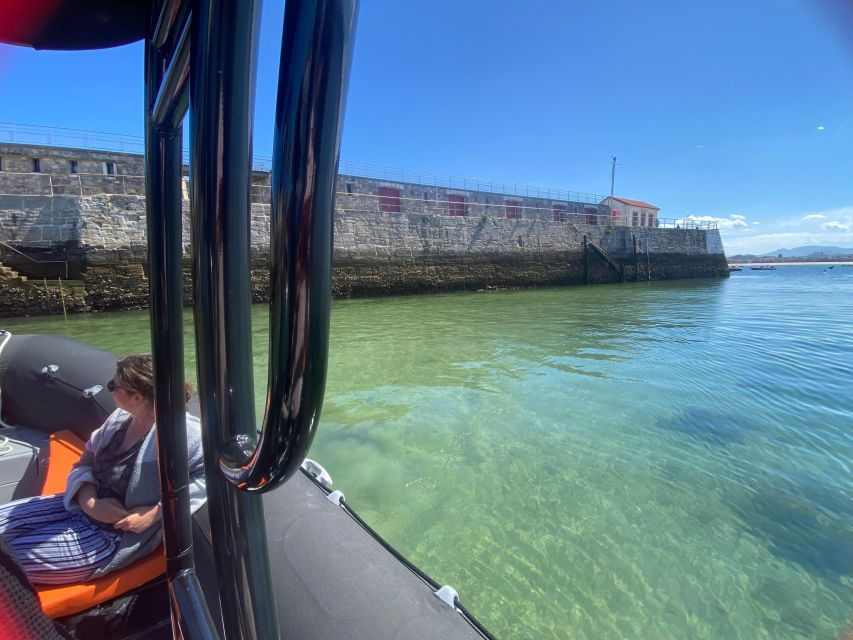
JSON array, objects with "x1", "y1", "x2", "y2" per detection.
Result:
[{"x1": 0, "y1": 0, "x2": 151, "y2": 50}]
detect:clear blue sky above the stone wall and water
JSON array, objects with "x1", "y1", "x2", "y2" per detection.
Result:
[{"x1": 0, "y1": 0, "x2": 853, "y2": 254}]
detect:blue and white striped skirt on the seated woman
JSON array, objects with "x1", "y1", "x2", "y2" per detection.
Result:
[{"x1": 0, "y1": 493, "x2": 121, "y2": 585}]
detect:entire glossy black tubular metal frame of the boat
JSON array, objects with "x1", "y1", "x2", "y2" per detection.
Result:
[{"x1": 145, "y1": 0, "x2": 356, "y2": 639}]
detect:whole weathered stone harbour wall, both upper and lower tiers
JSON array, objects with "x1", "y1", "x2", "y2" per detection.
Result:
[{"x1": 0, "y1": 144, "x2": 728, "y2": 316}]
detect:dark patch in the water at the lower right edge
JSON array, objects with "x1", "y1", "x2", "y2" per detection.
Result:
[{"x1": 741, "y1": 476, "x2": 853, "y2": 580}]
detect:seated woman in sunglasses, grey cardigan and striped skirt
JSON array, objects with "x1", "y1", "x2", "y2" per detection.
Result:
[{"x1": 0, "y1": 355, "x2": 206, "y2": 585}]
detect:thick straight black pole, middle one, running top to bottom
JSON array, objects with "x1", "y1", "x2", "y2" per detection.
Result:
[{"x1": 190, "y1": 0, "x2": 279, "y2": 640}]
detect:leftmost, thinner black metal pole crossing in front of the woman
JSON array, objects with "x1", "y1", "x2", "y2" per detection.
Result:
[{"x1": 145, "y1": 22, "x2": 217, "y2": 638}]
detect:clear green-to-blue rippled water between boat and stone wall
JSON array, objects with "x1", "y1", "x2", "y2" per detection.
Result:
[{"x1": 0, "y1": 267, "x2": 853, "y2": 640}]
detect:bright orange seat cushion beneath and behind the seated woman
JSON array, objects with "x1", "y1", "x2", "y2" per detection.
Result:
[{"x1": 36, "y1": 430, "x2": 166, "y2": 618}]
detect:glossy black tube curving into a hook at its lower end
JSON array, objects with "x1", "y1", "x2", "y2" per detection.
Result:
[{"x1": 220, "y1": 0, "x2": 356, "y2": 492}]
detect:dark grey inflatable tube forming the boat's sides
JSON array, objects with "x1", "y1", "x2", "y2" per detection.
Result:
[{"x1": 0, "y1": 333, "x2": 492, "y2": 640}]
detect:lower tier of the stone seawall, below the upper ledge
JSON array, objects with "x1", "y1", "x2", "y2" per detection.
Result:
[{"x1": 0, "y1": 192, "x2": 728, "y2": 316}]
